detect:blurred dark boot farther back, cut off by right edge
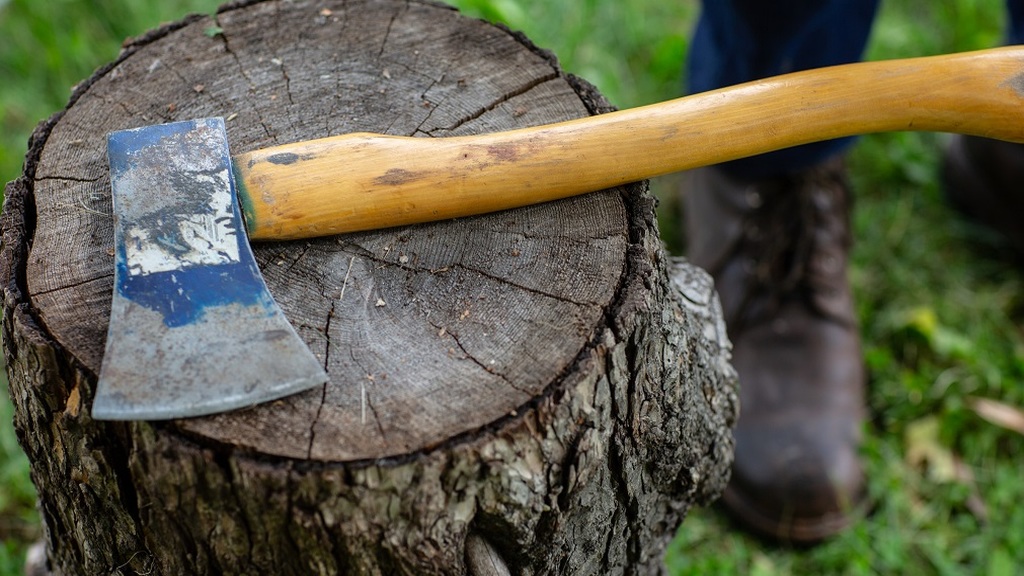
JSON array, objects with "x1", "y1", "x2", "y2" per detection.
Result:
[{"x1": 942, "y1": 135, "x2": 1024, "y2": 258}]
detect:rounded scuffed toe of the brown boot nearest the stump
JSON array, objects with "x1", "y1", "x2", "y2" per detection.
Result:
[{"x1": 724, "y1": 305, "x2": 864, "y2": 543}]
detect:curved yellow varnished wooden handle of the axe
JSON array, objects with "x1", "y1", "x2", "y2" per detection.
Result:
[{"x1": 232, "y1": 47, "x2": 1024, "y2": 240}]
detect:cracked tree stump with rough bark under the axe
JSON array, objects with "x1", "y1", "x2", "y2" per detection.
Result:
[{"x1": 2, "y1": 0, "x2": 736, "y2": 576}]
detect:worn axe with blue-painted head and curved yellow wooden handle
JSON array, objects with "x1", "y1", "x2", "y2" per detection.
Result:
[{"x1": 92, "y1": 48, "x2": 1024, "y2": 419}]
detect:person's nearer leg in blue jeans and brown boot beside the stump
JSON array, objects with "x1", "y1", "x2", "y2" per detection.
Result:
[{"x1": 683, "y1": 0, "x2": 878, "y2": 542}]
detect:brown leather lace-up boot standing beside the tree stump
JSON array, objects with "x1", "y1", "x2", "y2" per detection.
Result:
[{"x1": 683, "y1": 160, "x2": 865, "y2": 543}]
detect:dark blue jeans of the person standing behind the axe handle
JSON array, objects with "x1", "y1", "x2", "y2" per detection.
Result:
[{"x1": 687, "y1": 0, "x2": 1024, "y2": 178}]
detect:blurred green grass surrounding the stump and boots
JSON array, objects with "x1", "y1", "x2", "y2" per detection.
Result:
[{"x1": 0, "y1": 0, "x2": 1024, "y2": 576}]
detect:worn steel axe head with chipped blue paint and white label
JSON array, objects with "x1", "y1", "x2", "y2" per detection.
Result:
[{"x1": 92, "y1": 118, "x2": 328, "y2": 420}]
